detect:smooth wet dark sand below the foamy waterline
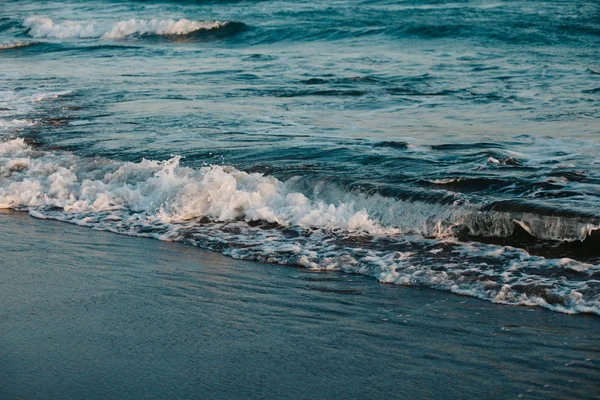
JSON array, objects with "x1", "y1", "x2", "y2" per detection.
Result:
[{"x1": 0, "y1": 212, "x2": 600, "y2": 399}]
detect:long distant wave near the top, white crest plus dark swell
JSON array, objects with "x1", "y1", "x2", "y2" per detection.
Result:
[{"x1": 14, "y1": 12, "x2": 597, "y2": 46}]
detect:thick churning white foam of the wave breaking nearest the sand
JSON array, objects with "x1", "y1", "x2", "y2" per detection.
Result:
[{"x1": 0, "y1": 139, "x2": 393, "y2": 234}]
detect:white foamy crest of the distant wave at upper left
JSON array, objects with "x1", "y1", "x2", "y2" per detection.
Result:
[{"x1": 23, "y1": 17, "x2": 243, "y2": 39}]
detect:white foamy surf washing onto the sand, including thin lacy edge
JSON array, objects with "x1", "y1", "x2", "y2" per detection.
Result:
[{"x1": 0, "y1": 139, "x2": 600, "y2": 315}]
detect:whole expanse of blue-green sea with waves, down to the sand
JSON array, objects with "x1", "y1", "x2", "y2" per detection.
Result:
[{"x1": 0, "y1": 0, "x2": 600, "y2": 314}]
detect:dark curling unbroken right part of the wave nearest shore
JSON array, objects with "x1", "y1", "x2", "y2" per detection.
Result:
[{"x1": 290, "y1": 178, "x2": 600, "y2": 247}]
